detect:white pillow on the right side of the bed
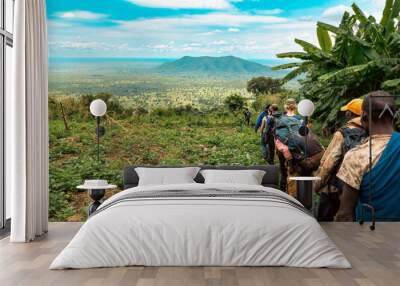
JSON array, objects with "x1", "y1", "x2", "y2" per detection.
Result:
[{"x1": 200, "y1": 170, "x2": 265, "y2": 185}]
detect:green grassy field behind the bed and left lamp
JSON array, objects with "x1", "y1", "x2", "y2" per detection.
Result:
[{"x1": 50, "y1": 107, "x2": 264, "y2": 220}]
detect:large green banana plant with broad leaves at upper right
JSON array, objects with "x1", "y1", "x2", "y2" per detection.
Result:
[{"x1": 274, "y1": 0, "x2": 400, "y2": 130}]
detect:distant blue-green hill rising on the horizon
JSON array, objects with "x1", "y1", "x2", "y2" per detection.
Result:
[{"x1": 157, "y1": 56, "x2": 274, "y2": 75}]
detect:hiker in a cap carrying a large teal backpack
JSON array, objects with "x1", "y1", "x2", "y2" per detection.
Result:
[{"x1": 274, "y1": 99, "x2": 324, "y2": 197}]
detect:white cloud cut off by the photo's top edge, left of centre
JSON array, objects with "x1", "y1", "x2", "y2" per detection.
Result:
[{"x1": 126, "y1": 0, "x2": 231, "y2": 10}]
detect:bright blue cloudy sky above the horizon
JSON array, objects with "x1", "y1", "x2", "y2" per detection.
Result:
[{"x1": 47, "y1": 0, "x2": 385, "y2": 59}]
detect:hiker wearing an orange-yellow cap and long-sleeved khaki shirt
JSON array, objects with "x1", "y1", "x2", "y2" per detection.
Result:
[{"x1": 314, "y1": 99, "x2": 366, "y2": 221}]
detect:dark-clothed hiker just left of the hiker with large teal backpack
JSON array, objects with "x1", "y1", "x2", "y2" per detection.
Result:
[{"x1": 260, "y1": 103, "x2": 279, "y2": 165}]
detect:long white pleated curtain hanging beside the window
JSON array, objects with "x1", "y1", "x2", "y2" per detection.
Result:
[{"x1": 6, "y1": 0, "x2": 49, "y2": 242}]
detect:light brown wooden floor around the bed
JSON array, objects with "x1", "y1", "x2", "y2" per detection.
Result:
[{"x1": 0, "y1": 223, "x2": 400, "y2": 286}]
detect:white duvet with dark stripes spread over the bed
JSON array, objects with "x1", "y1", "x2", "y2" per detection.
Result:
[{"x1": 50, "y1": 184, "x2": 351, "y2": 269}]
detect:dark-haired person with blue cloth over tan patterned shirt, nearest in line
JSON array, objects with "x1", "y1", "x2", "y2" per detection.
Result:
[{"x1": 336, "y1": 91, "x2": 400, "y2": 221}]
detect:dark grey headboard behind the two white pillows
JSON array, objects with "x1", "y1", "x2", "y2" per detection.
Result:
[{"x1": 123, "y1": 165, "x2": 280, "y2": 190}]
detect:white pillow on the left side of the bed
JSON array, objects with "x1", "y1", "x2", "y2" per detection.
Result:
[{"x1": 135, "y1": 167, "x2": 200, "y2": 186}]
